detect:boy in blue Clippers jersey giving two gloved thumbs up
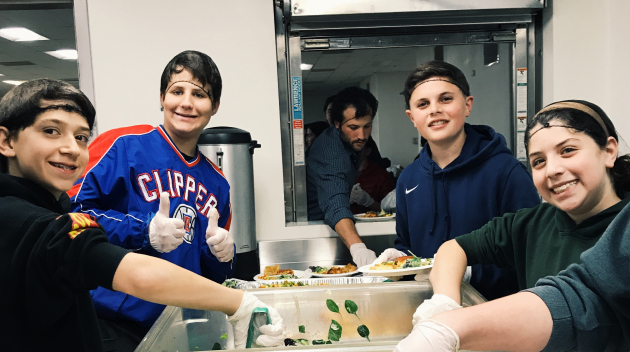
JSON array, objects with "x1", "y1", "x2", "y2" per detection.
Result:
[{"x1": 69, "y1": 51, "x2": 235, "y2": 351}]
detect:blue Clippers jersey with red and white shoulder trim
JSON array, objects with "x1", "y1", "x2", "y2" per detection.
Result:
[{"x1": 70, "y1": 126, "x2": 232, "y2": 326}]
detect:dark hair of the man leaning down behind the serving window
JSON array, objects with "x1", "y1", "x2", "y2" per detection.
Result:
[{"x1": 330, "y1": 87, "x2": 378, "y2": 124}]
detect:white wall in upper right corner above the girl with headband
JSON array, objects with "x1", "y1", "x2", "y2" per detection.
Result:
[{"x1": 543, "y1": 0, "x2": 630, "y2": 139}]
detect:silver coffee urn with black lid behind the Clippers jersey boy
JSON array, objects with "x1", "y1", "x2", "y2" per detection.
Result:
[{"x1": 197, "y1": 127, "x2": 260, "y2": 281}]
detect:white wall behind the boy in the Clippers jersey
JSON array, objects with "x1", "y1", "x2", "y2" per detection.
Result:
[{"x1": 75, "y1": 0, "x2": 395, "y2": 240}]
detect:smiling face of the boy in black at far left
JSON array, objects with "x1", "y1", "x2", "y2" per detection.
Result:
[{"x1": 0, "y1": 110, "x2": 90, "y2": 199}]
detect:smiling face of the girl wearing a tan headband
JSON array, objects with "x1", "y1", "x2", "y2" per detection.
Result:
[{"x1": 529, "y1": 121, "x2": 619, "y2": 223}]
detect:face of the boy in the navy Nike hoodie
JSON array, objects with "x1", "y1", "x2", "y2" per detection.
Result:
[{"x1": 406, "y1": 77, "x2": 473, "y2": 146}]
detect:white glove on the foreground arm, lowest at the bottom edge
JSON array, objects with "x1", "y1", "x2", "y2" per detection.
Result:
[{"x1": 394, "y1": 320, "x2": 459, "y2": 352}]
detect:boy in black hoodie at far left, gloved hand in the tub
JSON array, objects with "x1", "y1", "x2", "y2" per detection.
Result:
[{"x1": 0, "y1": 79, "x2": 284, "y2": 352}]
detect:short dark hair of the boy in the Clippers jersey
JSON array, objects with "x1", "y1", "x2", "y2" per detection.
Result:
[{"x1": 160, "y1": 50, "x2": 223, "y2": 106}]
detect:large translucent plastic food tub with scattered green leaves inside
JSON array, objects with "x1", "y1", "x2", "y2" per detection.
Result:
[{"x1": 136, "y1": 281, "x2": 494, "y2": 352}]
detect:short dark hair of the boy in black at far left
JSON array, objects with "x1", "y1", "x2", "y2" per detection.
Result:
[{"x1": 0, "y1": 78, "x2": 96, "y2": 173}]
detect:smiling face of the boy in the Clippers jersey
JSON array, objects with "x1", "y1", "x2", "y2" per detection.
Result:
[{"x1": 160, "y1": 69, "x2": 219, "y2": 152}]
